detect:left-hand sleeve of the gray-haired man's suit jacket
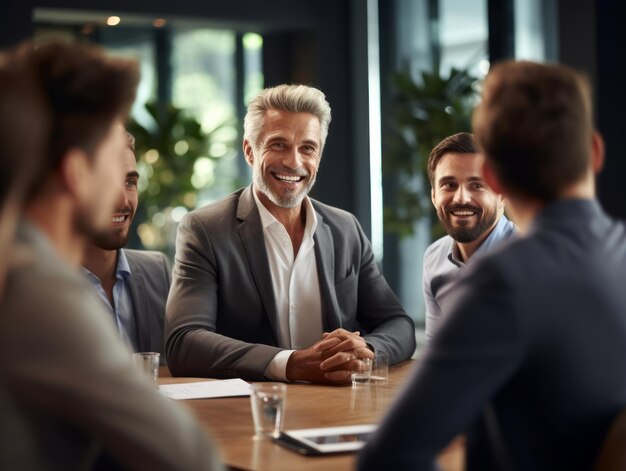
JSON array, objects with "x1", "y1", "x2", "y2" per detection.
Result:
[{"x1": 165, "y1": 213, "x2": 281, "y2": 381}]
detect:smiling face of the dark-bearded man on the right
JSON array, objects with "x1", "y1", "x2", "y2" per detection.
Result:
[{"x1": 431, "y1": 152, "x2": 504, "y2": 243}]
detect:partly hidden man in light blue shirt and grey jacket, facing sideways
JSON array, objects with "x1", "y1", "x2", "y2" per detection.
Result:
[{"x1": 83, "y1": 133, "x2": 171, "y2": 364}]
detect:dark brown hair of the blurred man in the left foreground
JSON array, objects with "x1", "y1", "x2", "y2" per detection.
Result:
[{"x1": 19, "y1": 41, "x2": 139, "y2": 196}]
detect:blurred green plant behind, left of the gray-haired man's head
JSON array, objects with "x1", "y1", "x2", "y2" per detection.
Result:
[{"x1": 127, "y1": 102, "x2": 235, "y2": 256}]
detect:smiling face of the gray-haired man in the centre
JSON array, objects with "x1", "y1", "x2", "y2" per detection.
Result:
[{"x1": 244, "y1": 110, "x2": 320, "y2": 211}]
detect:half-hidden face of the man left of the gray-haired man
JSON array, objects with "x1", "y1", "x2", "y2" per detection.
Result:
[{"x1": 94, "y1": 147, "x2": 139, "y2": 250}]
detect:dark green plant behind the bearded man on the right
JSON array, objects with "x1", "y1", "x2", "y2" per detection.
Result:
[{"x1": 382, "y1": 68, "x2": 478, "y2": 239}]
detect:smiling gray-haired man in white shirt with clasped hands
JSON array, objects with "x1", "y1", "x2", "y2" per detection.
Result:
[{"x1": 165, "y1": 85, "x2": 415, "y2": 383}]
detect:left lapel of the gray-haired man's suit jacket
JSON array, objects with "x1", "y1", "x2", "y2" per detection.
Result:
[{"x1": 237, "y1": 186, "x2": 280, "y2": 345}]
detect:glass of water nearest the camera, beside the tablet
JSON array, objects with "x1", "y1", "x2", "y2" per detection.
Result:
[{"x1": 250, "y1": 383, "x2": 287, "y2": 438}]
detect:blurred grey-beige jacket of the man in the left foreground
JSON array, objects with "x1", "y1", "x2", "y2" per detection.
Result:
[{"x1": 0, "y1": 223, "x2": 221, "y2": 470}]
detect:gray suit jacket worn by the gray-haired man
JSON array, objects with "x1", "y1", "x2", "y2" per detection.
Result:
[{"x1": 165, "y1": 186, "x2": 415, "y2": 380}]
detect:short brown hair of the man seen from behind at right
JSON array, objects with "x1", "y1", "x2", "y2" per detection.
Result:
[{"x1": 473, "y1": 61, "x2": 593, "y2": 202}]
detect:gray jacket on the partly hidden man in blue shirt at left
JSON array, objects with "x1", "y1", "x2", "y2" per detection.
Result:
[{"x1": 122, "y1": 249, "x2": 172, "y2": 365}]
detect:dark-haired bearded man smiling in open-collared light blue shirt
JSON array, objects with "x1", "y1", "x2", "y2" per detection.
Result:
[{"x1": 423, "y1": 132, "x2": 515, "y2": 342}]
